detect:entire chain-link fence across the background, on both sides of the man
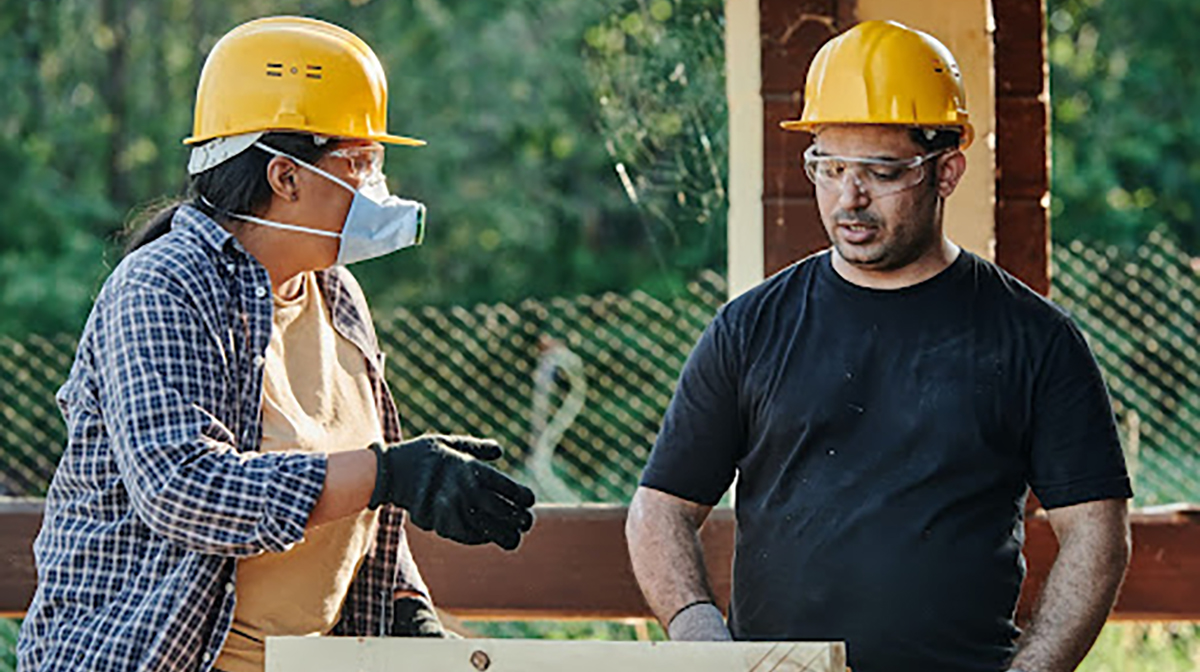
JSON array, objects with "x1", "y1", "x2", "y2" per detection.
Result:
[{"x1": 0, "y1": 242, "x2": 1200, "y2": 505}]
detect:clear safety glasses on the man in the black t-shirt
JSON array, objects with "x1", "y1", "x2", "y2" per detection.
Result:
[{"x1": 804, "y1": 145, "x2": 946, "y2": 198}]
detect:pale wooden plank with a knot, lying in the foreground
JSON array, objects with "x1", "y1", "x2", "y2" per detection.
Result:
[{"x1": 266, "y1": 637, "x2": 846, "y2": 672}]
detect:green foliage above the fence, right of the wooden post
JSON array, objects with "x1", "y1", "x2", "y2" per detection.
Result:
[{"x1": 1046, "y1": 0, "x2": 1200, "y2": 253}]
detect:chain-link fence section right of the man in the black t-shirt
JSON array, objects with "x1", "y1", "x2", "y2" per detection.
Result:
[{"x1": 1052, "y1": 232, "x2": 1200, "y2": 505}]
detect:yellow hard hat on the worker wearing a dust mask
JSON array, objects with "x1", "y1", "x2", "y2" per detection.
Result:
[{"x1": 184, "y1": 17, "x2": 425, "y2": 145}]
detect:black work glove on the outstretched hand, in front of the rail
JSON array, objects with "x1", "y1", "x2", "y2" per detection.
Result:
[{"x1": 371, "y1": 434, "x2": 534, "y2": 551}]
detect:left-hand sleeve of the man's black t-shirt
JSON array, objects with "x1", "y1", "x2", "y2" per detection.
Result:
[{"x1": 642, "y1": 311, "x2": 745, "y2": 505}]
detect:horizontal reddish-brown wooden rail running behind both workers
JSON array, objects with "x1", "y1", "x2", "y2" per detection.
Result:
[{"x1": 0, "y1": 499, "x2": 1200, "y2": 620}]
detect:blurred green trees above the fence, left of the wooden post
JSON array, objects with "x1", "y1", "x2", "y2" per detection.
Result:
[{"x1": 0, "y1": 0, "x2": 726, "y2": 335}]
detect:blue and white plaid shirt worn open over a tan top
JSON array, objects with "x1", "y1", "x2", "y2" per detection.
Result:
[{"x1": 17, "y1": 205, "x2": 427, "y2": 672}]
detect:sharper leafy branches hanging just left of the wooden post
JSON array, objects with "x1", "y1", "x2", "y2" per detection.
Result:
[{"x1": 584, "y1": 0, "x2": 728, "y2": 296}]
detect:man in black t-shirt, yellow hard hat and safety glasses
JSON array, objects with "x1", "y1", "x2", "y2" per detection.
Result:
[{"x1": 626, "y1": 22, "x2": 1132, "y2": 672}]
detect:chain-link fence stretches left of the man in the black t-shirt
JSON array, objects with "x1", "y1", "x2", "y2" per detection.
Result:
[{"x1": 0, "y1": 271, "x2": 726, "y2": 502}]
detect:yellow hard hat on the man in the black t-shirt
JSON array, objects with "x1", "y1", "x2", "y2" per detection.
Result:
[{"x1": 780, "y1": 20, "x2": 974, "y2": 148}]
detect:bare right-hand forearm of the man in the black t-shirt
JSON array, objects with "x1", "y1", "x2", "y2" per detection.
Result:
[{"x1": 1012, "y1": 503, "x2": 1129, "y2": 672}]
